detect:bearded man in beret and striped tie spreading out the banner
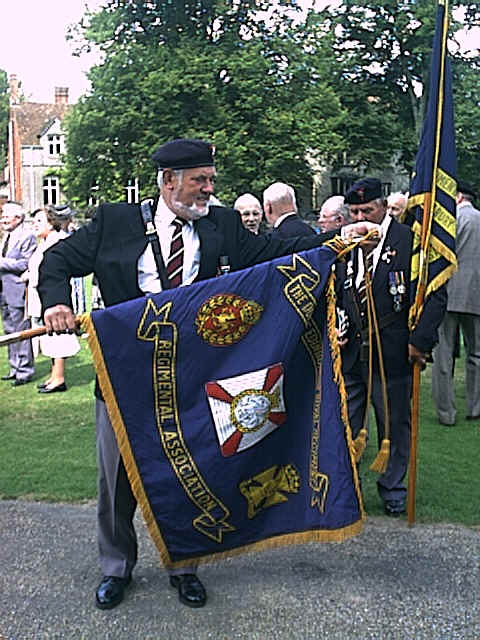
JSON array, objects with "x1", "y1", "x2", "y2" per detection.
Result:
[{"x1": 38, "y1": 139, "x2": 376, "y2": 609}]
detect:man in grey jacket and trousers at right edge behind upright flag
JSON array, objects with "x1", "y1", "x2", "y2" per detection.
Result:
[{"x1": 432, "y1": 181, "x2": 480, "y2": 426}]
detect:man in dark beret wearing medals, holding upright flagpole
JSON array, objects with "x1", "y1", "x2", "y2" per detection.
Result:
[{"x1": 339, "y1": 178, "x2": 446, "y2": 516}]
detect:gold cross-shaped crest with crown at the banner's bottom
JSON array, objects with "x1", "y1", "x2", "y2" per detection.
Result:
[{"x1": 240, "y1": 464, "x2": 300, "y2": 518}]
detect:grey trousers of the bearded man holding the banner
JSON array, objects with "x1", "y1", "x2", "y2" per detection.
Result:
[{"x1": 95, "y1": 399, "x2": 197, "y2": 578}]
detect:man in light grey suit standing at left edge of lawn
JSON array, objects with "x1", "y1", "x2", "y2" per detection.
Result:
[{"x1": 0, "y1": 202, "x2": 37, "y2": 387}]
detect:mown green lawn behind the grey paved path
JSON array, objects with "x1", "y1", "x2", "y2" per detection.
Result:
[{"x1": 0, "y1": 320, "x2": 480, "y2": 525}]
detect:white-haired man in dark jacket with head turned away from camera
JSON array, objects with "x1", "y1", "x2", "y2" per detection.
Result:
[{"x1": 263, "y1": 182, "x2": 316, "y2": 238}]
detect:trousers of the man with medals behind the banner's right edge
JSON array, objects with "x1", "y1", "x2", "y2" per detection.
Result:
[{"x1": 345, "y1": 360, "x2": 411, "y2": 500}]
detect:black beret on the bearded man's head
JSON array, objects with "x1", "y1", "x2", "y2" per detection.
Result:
[{"x1": 152, "y1": 138, "x2": 215, "y2": 169}]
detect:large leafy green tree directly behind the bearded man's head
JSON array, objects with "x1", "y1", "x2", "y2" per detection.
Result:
[{"x1": 65, "y1": 0, "x2": 345, "y2": 203}]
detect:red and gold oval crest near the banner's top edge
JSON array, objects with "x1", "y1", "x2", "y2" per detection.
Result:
[{"x1": 195, "y1": 293, "x2": 263, "y2": 347}]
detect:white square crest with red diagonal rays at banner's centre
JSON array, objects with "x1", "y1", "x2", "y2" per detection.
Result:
[{"x1": 205, "y1": 364, "x2": 287, "y2": 457}]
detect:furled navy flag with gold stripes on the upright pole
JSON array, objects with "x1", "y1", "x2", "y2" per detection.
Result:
[{"x1": 408, "y1": 0, "x2": 457, "y2": 328}]
